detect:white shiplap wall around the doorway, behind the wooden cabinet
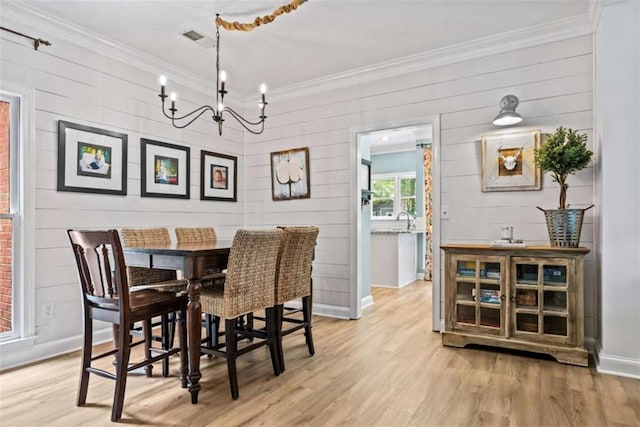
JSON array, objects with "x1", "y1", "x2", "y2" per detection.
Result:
[{"x1": 246, "y1": 36, "x2": 596, "y2": 336}]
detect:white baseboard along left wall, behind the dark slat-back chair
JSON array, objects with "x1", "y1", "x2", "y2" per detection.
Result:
[{"x1": 0, "y1": 328, "x2": 113, "y2": 372}]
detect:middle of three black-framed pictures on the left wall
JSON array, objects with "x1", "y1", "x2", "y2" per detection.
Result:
[{"x1": 140, "y1": 138, "x2": 191, "y2": 199}]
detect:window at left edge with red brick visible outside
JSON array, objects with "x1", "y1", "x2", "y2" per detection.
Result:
[{"x1": 0, "y1": 95, "x2": 19, "y2": 340}]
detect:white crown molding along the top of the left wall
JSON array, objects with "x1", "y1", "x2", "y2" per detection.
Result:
[{"x1": 2, "y1": 0, "x2": 245, "y2": 105}]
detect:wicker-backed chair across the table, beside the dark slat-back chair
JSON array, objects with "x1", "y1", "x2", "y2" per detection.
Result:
[{"x1": 120, "y1": 227, "x2": 189, "y2": 376}]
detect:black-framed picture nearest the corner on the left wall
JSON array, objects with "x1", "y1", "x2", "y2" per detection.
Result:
[{"x1": 200, "y1": 150, "x2": 238, "y2": 202}]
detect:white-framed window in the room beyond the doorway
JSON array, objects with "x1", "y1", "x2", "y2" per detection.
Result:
[{"x1": 372, "y1": 174, "x2": 416, "y2": 218}]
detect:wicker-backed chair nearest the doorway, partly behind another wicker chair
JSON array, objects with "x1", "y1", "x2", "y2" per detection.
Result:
[{"x1": 275, "y1": 226, "x2": 319, "y2": 372}]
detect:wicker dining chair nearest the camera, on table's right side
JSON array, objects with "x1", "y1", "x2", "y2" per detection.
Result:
[{"x1": 200, "y1": 229, "x2": 283, "y2": 400}]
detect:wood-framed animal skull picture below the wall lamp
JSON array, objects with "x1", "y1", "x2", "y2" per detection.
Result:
[{"x1": 482, "y1": 130, "x2": 541, "y2": 192}]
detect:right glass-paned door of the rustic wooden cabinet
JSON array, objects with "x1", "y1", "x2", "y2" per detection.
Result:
[{"x1": 511, "y1": 257, "x2": 572, "y2": 343}]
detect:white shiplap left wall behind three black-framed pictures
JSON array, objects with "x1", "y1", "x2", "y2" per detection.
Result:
[{"x1": 0, "y1": 18, "x2": 244, "y2": 366}]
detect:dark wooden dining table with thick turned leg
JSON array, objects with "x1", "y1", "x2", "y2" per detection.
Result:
[{"x1": 123, "y1": 240, "x2": 232, "y2": 404}]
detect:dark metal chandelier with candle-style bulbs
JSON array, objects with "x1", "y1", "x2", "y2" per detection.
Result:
[{"x1": 158, "y1": 14, "x2": 267, "y2": 135}]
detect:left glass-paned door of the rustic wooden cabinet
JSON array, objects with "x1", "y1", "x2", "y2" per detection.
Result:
[{"x1": 452, "y1": 256, "x2": 505, "y2": 335}]
